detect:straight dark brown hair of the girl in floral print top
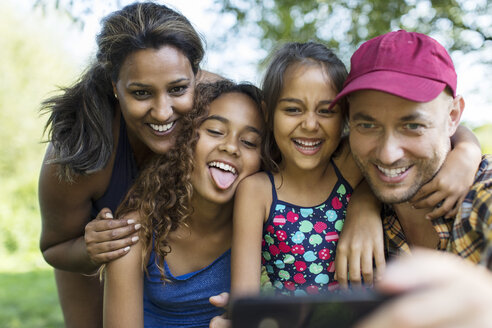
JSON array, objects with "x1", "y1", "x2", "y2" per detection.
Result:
[{"x1": 262, "y1": 42, "x2": 347, "y2": 172}]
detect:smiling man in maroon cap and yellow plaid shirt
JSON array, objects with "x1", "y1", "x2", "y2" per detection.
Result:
[{"x1": 334, "y1": 31, "x2": 492, "y2": 327}]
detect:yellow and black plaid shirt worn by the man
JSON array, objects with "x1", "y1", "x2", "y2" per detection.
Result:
[{"x1": 382, "y1": 155, "x2": 492, "y2": 270}]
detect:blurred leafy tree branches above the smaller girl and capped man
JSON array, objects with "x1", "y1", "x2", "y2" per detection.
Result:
[{"x1": 214, "y1": 0, "x2": 492, "y2": 63}]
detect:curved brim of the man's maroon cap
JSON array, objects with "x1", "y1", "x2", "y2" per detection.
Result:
[{"x1": 332, "y1": 71, "x2": 446, "y2": 105}]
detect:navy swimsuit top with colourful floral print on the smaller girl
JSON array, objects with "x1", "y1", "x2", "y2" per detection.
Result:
[{"x1": 261, "y1": 161, "x2": 352, "y2": 296}]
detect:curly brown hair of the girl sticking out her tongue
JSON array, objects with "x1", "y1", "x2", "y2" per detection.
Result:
[{"x1": 116, "y1": 80, "x2": 262, "y2": 281}]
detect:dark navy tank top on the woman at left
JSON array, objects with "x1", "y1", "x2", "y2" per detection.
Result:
[{"x1": 91, "y1": 118, "x2": 138, "y2": 219}]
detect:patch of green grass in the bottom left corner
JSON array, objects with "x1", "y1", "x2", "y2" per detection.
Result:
[{"x1": 0, "y1": 270, "x2": 63, "y2": 328}]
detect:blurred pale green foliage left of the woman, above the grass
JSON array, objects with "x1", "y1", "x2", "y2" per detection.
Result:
[{"x1": 0, "y1": 3, "x2": 79, "y2": 271}]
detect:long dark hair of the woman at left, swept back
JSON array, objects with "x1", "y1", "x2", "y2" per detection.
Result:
[{"x1": 41, "y1": 2, "x2": 204, "y2": 180}]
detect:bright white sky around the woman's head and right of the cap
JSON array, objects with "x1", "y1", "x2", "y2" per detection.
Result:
[{"x1": 20, "y1": 0, "x2": 492, "y2": 126}]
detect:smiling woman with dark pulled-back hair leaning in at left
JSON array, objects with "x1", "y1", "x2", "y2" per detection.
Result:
[{"x1": 39, "y1": 2, "x2": 219, "y2": 328}]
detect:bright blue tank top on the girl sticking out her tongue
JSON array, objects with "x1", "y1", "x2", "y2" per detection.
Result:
[{"x1": 144, "y1": 249, "x2": 231, "y2": 328}]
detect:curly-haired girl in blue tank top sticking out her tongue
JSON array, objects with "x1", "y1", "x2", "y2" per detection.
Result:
[{"x1": 104, "y1": 81, "x2": 263, "y2": 328}]
